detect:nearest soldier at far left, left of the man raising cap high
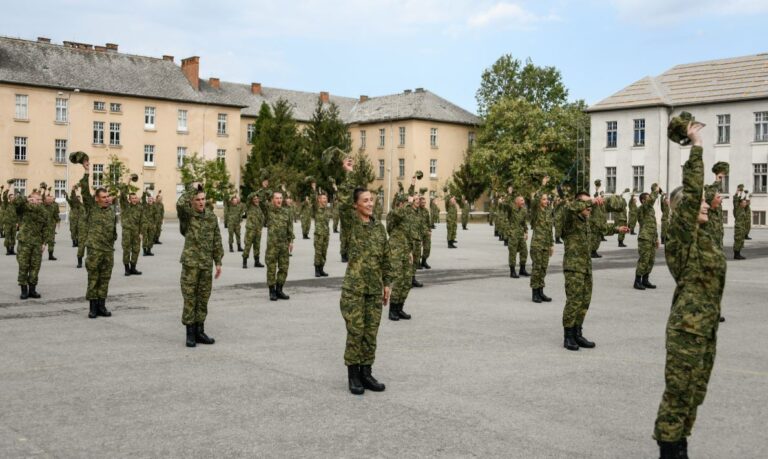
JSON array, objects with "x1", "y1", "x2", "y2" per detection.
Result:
[{"x1": 13, "y1": 191, "x2": 53, "y2": 300}]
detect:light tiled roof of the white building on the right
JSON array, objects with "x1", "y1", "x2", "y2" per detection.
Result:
[{"x1": 587, "y1": 53, "x2": 768, "y2": 112}]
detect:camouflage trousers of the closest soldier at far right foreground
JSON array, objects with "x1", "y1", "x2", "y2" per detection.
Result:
[{"x1": 653, "y1": 328, "x2": 717, "y2": 442}]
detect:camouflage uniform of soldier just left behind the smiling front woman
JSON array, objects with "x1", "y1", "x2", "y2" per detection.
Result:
[{"x1": 265, "y1": 206, "x2": 294, "y2": 287}]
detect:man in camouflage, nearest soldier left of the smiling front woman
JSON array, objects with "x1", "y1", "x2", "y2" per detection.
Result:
[{"x1": 176, "y1": 184, "x2": 224, "y2": 347}]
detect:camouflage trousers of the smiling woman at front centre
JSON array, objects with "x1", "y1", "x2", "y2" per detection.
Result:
[{"x1": 340, "y1": 290, "x2": 382, "y2": 366}]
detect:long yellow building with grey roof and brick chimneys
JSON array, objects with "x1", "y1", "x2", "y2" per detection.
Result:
[{"x1": 0, "y1": 37, "x2": 479, "y2": 216}]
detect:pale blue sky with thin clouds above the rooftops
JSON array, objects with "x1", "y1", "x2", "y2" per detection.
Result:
[{"x1": 0, "y1": 0, "x2": 768, "y2": 112}]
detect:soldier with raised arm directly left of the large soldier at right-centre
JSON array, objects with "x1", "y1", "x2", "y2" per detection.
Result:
[{"x1": 530, "y1": 180, "x2": 554, "y2": 303}]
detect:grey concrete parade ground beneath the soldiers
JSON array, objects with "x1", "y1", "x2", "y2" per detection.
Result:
[{"x1": 0, "y1": 223, "x2": 768, "y2": 458}]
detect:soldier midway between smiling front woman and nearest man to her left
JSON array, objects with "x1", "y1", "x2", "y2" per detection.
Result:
[{"x1": 264, "y1": 191, "x2": 294, "y2": 301}]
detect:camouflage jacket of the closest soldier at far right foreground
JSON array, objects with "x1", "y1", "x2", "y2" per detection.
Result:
[{"x1": 664, "y1": 147, "x2": 726, "y2": 338}]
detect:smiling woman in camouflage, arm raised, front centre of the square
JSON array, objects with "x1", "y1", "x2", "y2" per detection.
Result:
[{"x1": 339, "y1": 158, "x2": 392, "y2": 395}]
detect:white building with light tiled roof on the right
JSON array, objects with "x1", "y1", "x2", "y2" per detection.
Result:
[{"x1": 588, "y1": 53, "x2": 768, "y2": 226}]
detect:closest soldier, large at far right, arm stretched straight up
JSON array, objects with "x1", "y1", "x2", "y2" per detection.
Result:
[{"x1": 653, "y1": 124, "x2": 726, "y2": 458}]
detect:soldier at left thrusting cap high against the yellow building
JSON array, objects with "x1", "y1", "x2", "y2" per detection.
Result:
[{"x1": 80, "y1": 160, "x2": 117, "y2": 319}]
